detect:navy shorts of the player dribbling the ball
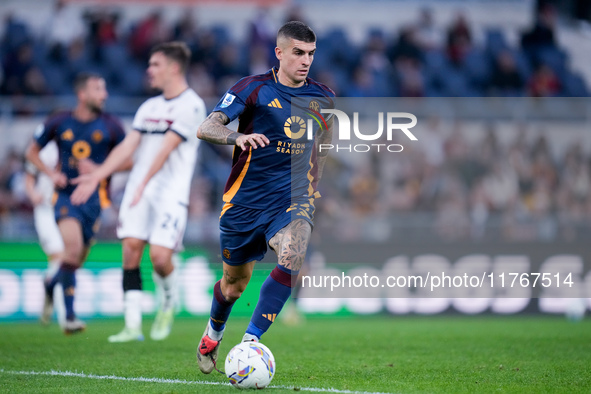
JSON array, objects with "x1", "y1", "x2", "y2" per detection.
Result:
[{"x1": 220, "y1": 199, "x2": 314, "y2": 266}]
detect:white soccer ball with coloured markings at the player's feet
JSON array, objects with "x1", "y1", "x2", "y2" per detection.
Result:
[{"x1": 225, "y1": 342, "x2": 275, "y2": 389}]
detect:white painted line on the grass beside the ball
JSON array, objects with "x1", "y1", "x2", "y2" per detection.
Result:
[{"x1": 0, "y1": 369, "x2": 394, "y2": 394}]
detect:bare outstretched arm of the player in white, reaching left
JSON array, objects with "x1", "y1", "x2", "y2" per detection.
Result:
[{"x1": 70, "y1": 130, "x2": 142, "y2": 205}]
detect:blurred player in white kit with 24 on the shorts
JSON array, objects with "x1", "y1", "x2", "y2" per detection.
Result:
[{"x1": 72, "y1": 42, "x2": 206, "y2": 342}]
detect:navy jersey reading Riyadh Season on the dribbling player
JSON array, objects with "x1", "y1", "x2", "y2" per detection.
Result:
[{"x1": 213, "y1": 68, "x2": 335, "y2": 209}]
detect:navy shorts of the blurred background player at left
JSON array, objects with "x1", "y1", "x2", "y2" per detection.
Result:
[{"x1": 55, "y1": 193, "x2": 101, "y2": 246}]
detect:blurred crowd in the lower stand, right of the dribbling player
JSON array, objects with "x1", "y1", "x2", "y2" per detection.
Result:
[{"x1": 317, "y1": 117, "x2": 591, "y2": 242}]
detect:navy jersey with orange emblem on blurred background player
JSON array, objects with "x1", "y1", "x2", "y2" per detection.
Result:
[{"x1": 34, "y1": 111, "x2": 125, "y2": 203}]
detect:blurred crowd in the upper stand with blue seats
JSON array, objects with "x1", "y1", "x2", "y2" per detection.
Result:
[{"x1": 0, "y1": 0, "x2": 588, "y2": 112}]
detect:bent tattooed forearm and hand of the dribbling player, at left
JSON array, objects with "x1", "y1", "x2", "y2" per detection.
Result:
[{"x1": 197, "y1": 111, "x2": 269, "y2": 150}]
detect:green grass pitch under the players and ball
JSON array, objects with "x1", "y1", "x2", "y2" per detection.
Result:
[{"x1": 0, "y1": 316, "x2": 591, "y2": 393}]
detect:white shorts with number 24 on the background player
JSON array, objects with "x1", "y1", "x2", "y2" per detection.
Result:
[{"x1": 117, "y1": 187, "x2": 188, "y2": 251}]
